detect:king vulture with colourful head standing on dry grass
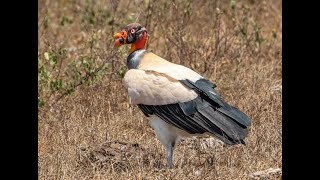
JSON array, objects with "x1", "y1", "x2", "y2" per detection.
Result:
[{"x1": 114, "y1": 23, "x2": 251, "y2": 168}]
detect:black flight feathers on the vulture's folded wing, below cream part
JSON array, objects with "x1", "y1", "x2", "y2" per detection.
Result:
[{"x1": 138, "y1": 79, "x2": 251, "y2": 144}]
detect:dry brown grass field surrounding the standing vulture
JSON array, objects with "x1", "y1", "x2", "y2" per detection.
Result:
[{"x1": 38, "y1": 0, "x2": 282, "y2": 179}]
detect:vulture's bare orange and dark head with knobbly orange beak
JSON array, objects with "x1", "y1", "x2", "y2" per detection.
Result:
[{"x1": 113, "y1": 23, "x2": 147, "y2": 52}]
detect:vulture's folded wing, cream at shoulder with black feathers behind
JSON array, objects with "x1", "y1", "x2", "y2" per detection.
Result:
[{"x1": 124, "y1": 63, "x2": 251, "y2": 144}]
